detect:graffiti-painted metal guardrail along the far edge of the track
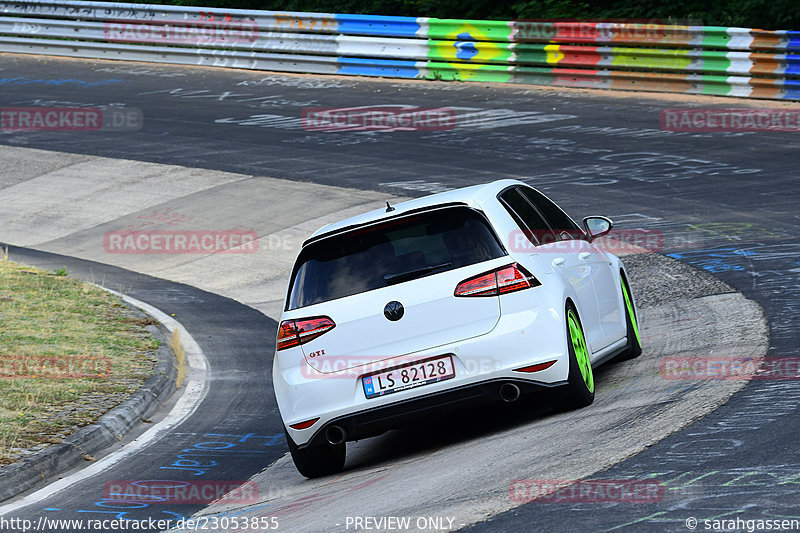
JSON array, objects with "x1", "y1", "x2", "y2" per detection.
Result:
[{"x1": 0, "y1": 0, "x2": 800, "y2": 100}]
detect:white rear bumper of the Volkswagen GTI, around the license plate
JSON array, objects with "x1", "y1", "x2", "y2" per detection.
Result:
[{"x1": 272, "y1": 291, "x2": 569, "y2": 447}]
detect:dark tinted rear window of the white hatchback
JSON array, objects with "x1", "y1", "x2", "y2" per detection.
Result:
[{"x1": 286, "y1": 206, "x2": 506, "y2": 310}]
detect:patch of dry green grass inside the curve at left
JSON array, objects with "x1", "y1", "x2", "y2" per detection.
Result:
[{"x1": 0, "y1": 254, "x2": 158, "y2": 465}]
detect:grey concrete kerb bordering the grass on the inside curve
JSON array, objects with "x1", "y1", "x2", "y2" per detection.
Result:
[{"x1": 0, "y1": 287, "x2": 178, "y2": 502}]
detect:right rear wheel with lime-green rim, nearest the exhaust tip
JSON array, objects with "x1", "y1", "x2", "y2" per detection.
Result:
[{"x1": 553, "y1": 305, "x2": 594, "y2": 411}]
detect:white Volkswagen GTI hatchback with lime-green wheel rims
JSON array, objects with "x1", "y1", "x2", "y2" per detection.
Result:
[{"x1": 273, "y1": 180, "x2": 641, "y2": 477}]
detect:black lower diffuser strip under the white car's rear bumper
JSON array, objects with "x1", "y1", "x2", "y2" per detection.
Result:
[{"x1": 298, "y1": 378, "x2": 566, "y2": 448}]
